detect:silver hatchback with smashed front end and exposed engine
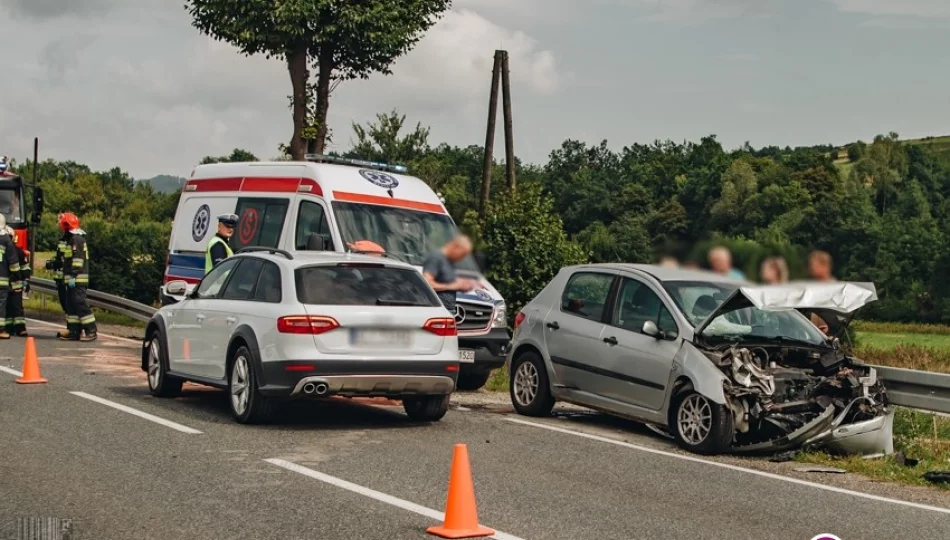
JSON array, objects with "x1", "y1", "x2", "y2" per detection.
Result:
[{"x1": 508, "y1": 264, "x2": 893, "y2": 455}]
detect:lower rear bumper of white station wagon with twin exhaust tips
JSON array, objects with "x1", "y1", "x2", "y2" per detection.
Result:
[{"x1": 260, "y1": 360, "x2": 459, "y2": 397}]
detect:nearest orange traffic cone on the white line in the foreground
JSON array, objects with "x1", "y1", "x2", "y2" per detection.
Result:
[{"x1": 426, "y1": 444, "x2": 495, "y2": 538}]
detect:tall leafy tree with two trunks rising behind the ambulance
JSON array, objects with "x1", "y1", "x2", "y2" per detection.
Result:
[{"x1": 185, "y1": 0, "x2": 451, "y2": 160}]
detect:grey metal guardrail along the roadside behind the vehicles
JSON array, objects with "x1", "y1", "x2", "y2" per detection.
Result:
[{"x1": 22, "y1": 278, "x2": 950, "y2": 414}]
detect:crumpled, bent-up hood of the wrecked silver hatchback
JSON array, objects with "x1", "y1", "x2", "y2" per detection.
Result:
[{"x1": 697, "y1": 281, "x2": 877, "y2": 337}]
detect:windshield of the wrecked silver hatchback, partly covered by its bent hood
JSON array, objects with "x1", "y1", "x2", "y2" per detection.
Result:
[{"x1": 663, "y1": 281, "x2": 826, "y2": 345}]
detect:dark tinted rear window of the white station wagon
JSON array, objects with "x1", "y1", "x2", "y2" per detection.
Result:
[{"x1": 294, "y1": 264, "x2": 441, "y2": 307}]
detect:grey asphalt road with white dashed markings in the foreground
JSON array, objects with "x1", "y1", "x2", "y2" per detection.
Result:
[{"x1": 0, "y1": 324, "x2": 950, "y2": 540}]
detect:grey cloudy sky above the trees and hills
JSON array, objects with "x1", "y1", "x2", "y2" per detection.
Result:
[{"x1": 0, "y1": 0, "x2": 950, "y2": 178}]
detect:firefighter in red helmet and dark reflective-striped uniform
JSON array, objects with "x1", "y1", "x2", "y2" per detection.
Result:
[{"x1": 59, "y1": 212, "x2": 98, "y2": 341}]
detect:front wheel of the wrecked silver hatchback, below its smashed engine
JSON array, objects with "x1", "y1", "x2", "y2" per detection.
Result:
[{"x1": 670, "y1": 390, "x2": 735, "y2": 454}]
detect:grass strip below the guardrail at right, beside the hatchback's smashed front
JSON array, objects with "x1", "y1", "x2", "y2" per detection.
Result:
[{"x1": 795, "y1": 407, "x2": 950, "y2": 491}]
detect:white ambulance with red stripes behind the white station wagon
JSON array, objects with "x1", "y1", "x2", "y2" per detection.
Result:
[{"x1": 160, "y1": 155, "x2": 510, "y2": 390}]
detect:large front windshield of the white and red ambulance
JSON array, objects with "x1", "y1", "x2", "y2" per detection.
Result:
[{"x1": 333, "y1": 202, "x2": 478, "y2": 272}]
